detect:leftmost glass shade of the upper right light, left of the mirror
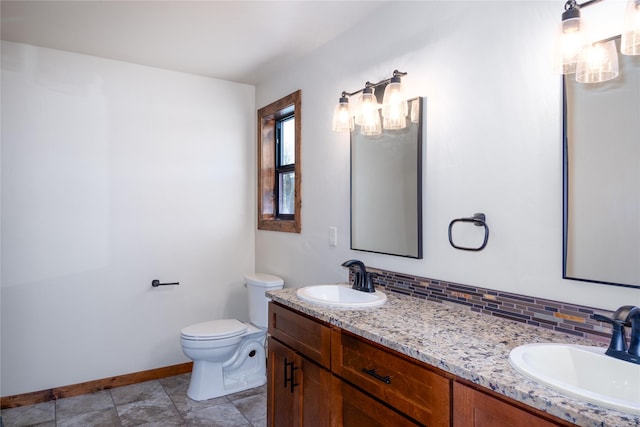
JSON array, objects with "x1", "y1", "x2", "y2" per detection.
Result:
[{"x1": 553, "y1": 11, "x2": 587, "y2": 74}]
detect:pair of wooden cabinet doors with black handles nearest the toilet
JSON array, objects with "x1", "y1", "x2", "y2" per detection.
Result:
[{"x1": 267, "y1": 338, "x2": 331, "y2": 427}]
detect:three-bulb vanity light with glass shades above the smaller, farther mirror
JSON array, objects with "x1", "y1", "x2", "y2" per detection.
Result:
[{"x1": 332, "y1": 70, "x2": 409, "y2": 135}]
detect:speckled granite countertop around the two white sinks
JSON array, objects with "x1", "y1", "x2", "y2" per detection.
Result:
[{"x1": 267, "y1": 288, "x2": 640, "y2": 427}]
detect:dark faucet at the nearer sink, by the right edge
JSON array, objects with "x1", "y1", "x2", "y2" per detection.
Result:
[{"x1": 593, "y1": 305, "x2": 640, "y2": 364}]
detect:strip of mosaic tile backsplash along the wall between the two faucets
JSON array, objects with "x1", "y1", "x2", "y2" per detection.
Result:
[{"x1": 367, "y1": 267, "x2": 613, "y2": 344}]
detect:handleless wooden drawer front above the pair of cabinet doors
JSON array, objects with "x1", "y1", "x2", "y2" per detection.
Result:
[{"x1": 269, "y1": 302, "x2": 331, "y2": 368}]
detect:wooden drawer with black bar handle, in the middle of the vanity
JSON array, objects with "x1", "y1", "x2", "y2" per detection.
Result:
[{"x1": 331, "y1": 330, "x2": 451, "y2": 427}]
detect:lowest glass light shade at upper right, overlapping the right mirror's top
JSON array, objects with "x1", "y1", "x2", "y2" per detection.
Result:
[{"x1": 576, "y1": 40, "x2": 620, "y2": 83}]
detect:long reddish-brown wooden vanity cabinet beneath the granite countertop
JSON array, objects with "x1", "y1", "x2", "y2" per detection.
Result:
[{"x1": 267, "y1": 303, "x2": 573, "y2": 427}]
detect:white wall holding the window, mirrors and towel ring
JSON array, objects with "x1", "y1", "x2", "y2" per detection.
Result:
[{"x1": 256, "y1": 1, "x2": 640, "y2": 309}]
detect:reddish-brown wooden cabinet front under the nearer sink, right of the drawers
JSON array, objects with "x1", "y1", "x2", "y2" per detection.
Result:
[{"x1": 453, "y1": 383, "x2": 569, "y2": 427}]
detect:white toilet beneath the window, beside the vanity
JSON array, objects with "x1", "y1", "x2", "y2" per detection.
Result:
[{"x1": 180, "y1": 273, "x2": 284, "y2": 401}]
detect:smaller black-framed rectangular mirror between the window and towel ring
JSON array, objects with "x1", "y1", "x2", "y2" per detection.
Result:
[{"x1": 351, "y1": 98, "x2": 424, "y2": 258}]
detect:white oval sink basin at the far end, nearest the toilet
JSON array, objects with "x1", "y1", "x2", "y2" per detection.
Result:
[{"x1": 297, "y1": 284, "x2": 387, "y2": 308}]
